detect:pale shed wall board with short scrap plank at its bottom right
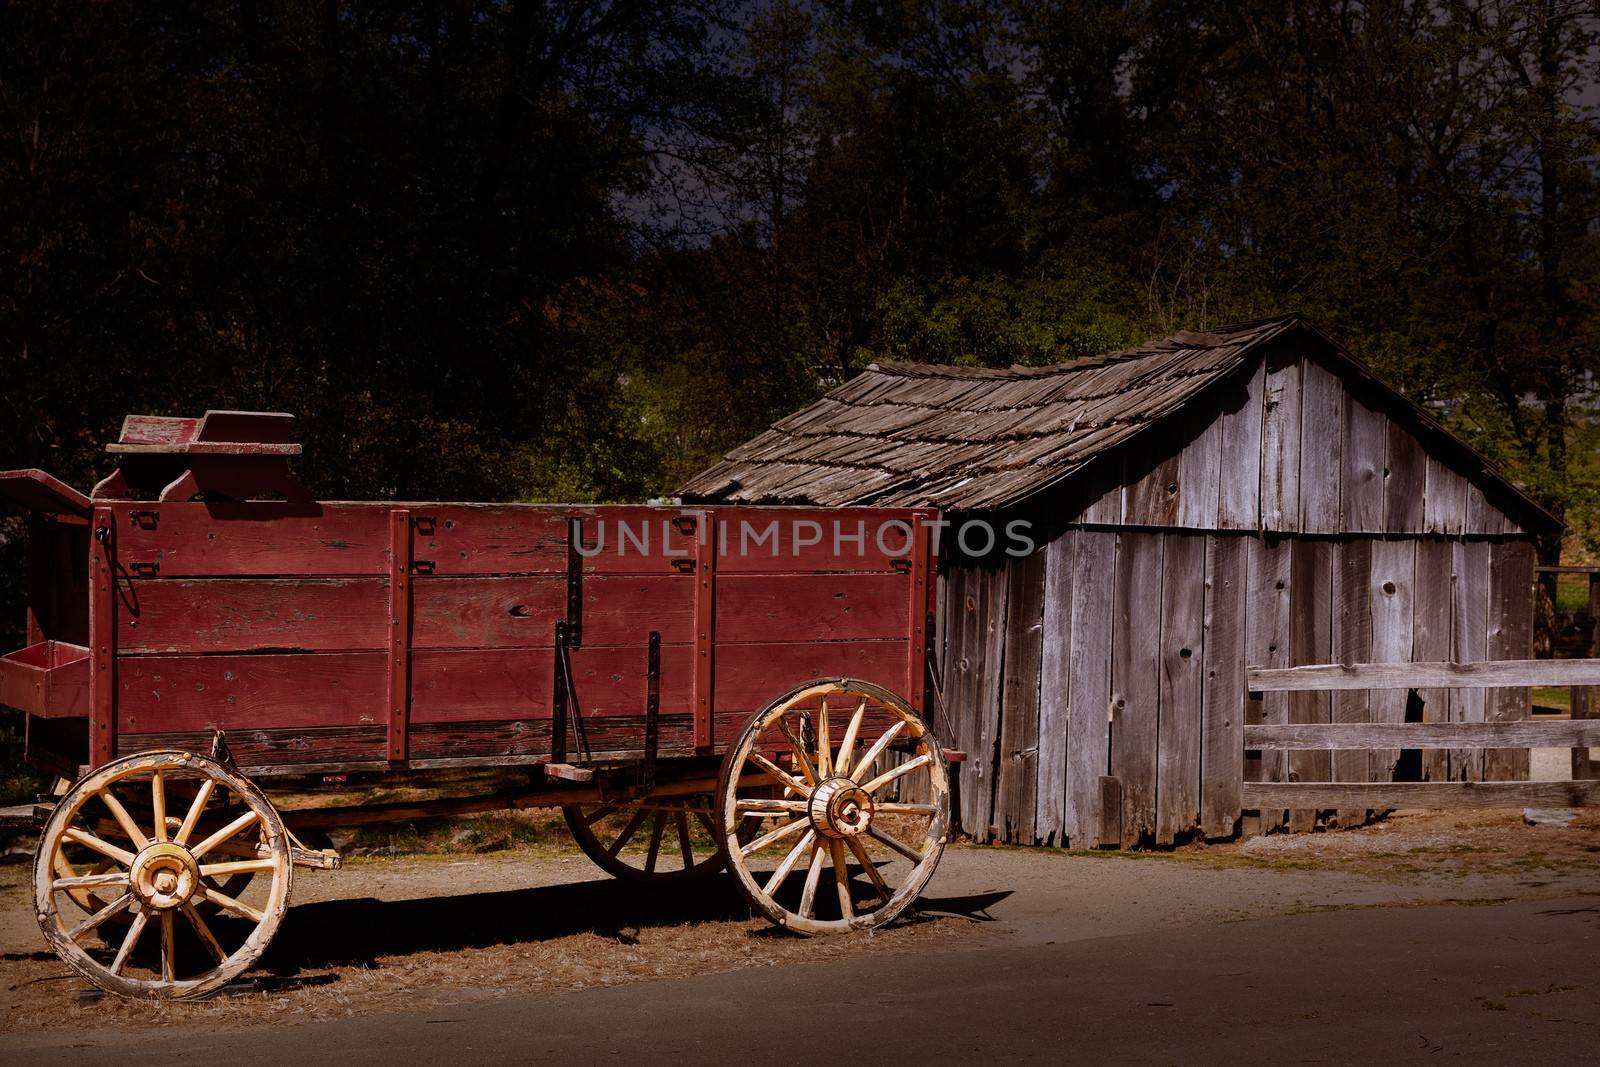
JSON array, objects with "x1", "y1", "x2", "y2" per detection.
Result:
[{"x1": 1064, "y1": 530, "x2": 1117, "y2": 848}]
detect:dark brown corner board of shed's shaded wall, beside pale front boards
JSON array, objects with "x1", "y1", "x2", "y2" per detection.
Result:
[{"x1": 994, "y1": 549, "x2": 1045, "y2": 845}]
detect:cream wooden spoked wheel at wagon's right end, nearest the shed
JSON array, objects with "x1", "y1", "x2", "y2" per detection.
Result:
[{"x1": 717, "y1": 678, "x2": 950, "y2": 934}]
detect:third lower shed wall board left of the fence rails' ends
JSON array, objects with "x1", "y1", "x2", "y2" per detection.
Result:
[{"x1": 1110, "y1": 533, "x2": 1165, "y2": 845}]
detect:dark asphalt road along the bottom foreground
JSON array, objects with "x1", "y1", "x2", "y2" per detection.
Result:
[{"x1": 15, "y1": 891, "x2": 1600, "y2": 1067}]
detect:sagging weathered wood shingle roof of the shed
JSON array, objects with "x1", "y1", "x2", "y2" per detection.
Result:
[{"x1": 680, "y1": 315, "x2": 1558, "y2": 528}]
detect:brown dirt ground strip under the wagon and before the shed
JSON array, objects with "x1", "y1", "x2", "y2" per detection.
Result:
[{"x1": 0, "y1": 811, "x2": 1600, "y2": 1040}]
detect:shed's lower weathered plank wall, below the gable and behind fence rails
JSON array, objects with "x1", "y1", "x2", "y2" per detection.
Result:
[{"x1": 944, "y1": 528, "x2": 1533, "y2": 848}]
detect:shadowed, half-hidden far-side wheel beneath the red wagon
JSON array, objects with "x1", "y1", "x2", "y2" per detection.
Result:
[{"x1": 562, "y1": 793, "x2": 758, "y2": 881}]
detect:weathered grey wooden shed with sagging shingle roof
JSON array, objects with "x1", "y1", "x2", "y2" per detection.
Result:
[{"x1": 682, "y1": 317, "x2": 1558, "y2": 846}]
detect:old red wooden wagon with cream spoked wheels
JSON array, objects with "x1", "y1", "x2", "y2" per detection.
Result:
[{"x1": 0, "y1": 411, "x2": 949, "y2": 997}]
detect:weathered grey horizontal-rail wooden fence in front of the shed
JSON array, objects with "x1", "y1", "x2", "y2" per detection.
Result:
[{"x1": 1242, "y1": 659, "x2": 1600, "y2": 811}]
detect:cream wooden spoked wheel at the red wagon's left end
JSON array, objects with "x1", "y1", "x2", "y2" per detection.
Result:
[{"x1": 34, "y1": 752, "x2": 293, "y2": 998}]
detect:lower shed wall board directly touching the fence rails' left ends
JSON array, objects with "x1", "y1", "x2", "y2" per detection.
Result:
[{"x1": 1200, "y1": 537, "x2": 1250, "y2": 838}]
